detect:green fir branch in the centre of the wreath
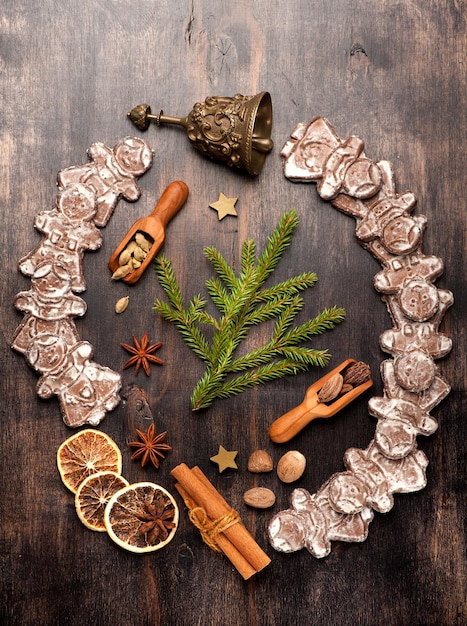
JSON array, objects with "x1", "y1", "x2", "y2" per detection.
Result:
[{"x1": 154, "y1": 211, "x2": 345, "y2": 411}]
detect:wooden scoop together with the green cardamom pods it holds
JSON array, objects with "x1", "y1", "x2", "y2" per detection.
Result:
[{"x1": 108, "y1": 180, "x2": 188, "y2": 284}]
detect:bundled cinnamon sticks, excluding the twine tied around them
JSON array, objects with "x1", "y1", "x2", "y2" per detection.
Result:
[{"x1": 171, "y1": 463, "x2": 271, "y2": 580}]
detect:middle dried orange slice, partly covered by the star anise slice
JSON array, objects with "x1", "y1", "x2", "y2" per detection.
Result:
[{"x1": 75, "y1": 472, "x2": 128, "y2": 532}]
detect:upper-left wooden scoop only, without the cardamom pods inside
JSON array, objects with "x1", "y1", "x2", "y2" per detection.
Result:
[{"x1": 108, "y1": 180, "x2": 188, "y2": 284}]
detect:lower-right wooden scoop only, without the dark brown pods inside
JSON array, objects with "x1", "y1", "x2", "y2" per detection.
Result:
[{"x1": 269, "y1": 359, "x2": 373, "y2": 443}]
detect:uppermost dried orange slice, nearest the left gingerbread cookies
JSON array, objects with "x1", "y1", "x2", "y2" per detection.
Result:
[{"x1": 57, "y1": 428, "x2": 122, "y2": 493}]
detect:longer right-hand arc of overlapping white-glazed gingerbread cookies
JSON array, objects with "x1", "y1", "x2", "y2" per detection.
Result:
[{"x1": 268, "y1": 118, "x2": 453, "y2": 558}]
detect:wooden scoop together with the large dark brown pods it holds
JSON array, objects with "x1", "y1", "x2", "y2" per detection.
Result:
[{"x1": 269, "y1": 359, "x2": 373, "y2": 443}]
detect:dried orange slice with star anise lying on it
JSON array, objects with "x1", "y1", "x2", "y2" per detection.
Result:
[{"x1": 104, "y1": 483, "x2": 179, "y2": 553}]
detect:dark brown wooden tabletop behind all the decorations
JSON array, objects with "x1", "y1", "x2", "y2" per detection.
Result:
[{"x1": 0, "y1": 0, "x2": 467, "y2": 626}]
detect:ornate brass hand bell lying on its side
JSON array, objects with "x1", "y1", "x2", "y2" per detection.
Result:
[{"x1": 128, "y1": 91, "x2": 274, "y2": 176}]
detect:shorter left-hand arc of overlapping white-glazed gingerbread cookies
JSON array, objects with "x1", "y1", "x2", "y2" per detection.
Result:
[{"x1": 11, "y1": 137, "x2": 152, "y2": 428}]
